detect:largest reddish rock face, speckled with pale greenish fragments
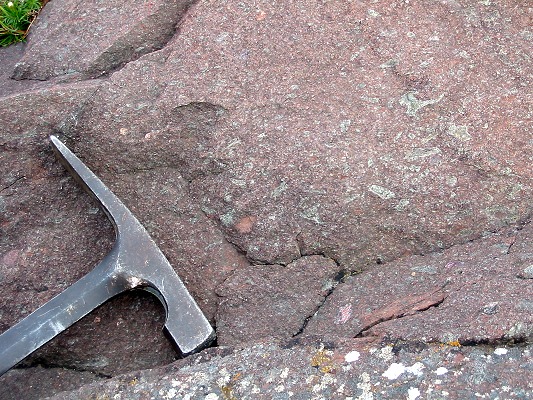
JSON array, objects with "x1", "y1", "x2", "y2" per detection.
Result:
[{"x1": 72, "y1": 1, "x2": 531, "y2": 270}]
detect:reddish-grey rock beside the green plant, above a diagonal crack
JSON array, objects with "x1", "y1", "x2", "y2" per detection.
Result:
[{"x1": 13, "y1": 0, "x2": 194, "y2": 80}]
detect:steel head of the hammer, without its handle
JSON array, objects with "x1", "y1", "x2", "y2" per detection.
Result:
[{"x1": 50, "y1": 136, "x2": 215, "y2": 355}]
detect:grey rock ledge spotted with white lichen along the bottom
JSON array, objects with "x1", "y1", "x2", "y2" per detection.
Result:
[{"x1": 53, "y1": 340, "x2": 533, "y2": 400}]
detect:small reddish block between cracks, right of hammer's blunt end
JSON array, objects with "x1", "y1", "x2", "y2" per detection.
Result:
[{"x1": 216, "y1": 256, "x2": 342, "y2": 345}]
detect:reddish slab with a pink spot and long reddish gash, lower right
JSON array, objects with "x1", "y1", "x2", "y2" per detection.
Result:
[{"x1": 304, "y1": 224, "x2": 533, "y2": 344}]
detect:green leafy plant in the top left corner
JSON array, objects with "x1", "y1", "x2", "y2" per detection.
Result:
[{"x1": 0, "y1": 0, "x2": 45, "y2": 46}]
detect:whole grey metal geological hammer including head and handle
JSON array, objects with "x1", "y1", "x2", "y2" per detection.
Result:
[{"x1": 0, "y1": 136, "x2": 215, "y2": 375}]
